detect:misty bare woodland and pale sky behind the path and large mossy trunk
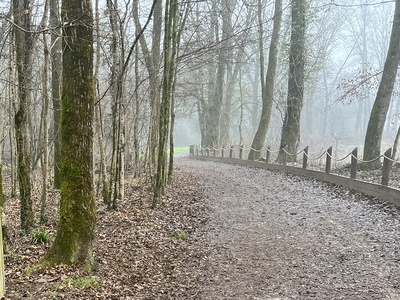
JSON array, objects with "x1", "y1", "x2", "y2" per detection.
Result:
[{"x1": 0, "y1": 0, "x2": 400, "y2": 234}]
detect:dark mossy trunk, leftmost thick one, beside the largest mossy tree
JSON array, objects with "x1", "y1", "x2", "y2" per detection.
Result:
[{"x1": 13, "y1": 0, "x2": 34, "y2": 231}]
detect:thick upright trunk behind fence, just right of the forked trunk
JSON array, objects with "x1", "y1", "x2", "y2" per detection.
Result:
[{"x1": 277, "y1": 0, "x2": 306, "y2": 161}]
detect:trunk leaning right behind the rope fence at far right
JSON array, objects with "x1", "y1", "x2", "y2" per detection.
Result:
[{"x1": 363, "y1": 0, "x2": 400, "y2": 169}]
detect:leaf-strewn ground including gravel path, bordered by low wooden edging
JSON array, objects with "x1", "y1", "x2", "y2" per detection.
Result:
[{"x1": 5, "y1": 157, "x2": 400, "y2": 300}]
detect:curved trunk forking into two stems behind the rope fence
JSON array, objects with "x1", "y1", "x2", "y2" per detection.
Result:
[{"x1": 248, "y1": 0, "x2": 282, "y2": 160}]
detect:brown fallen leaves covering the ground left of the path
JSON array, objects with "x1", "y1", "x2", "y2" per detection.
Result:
[{"x1": 5, "y1": 170, "x2": 206, "y2": 299}]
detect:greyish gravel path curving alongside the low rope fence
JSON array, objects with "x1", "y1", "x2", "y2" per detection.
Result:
[{"x1": 176, "y1": 158, "x2": 400, "y2": 300}]
